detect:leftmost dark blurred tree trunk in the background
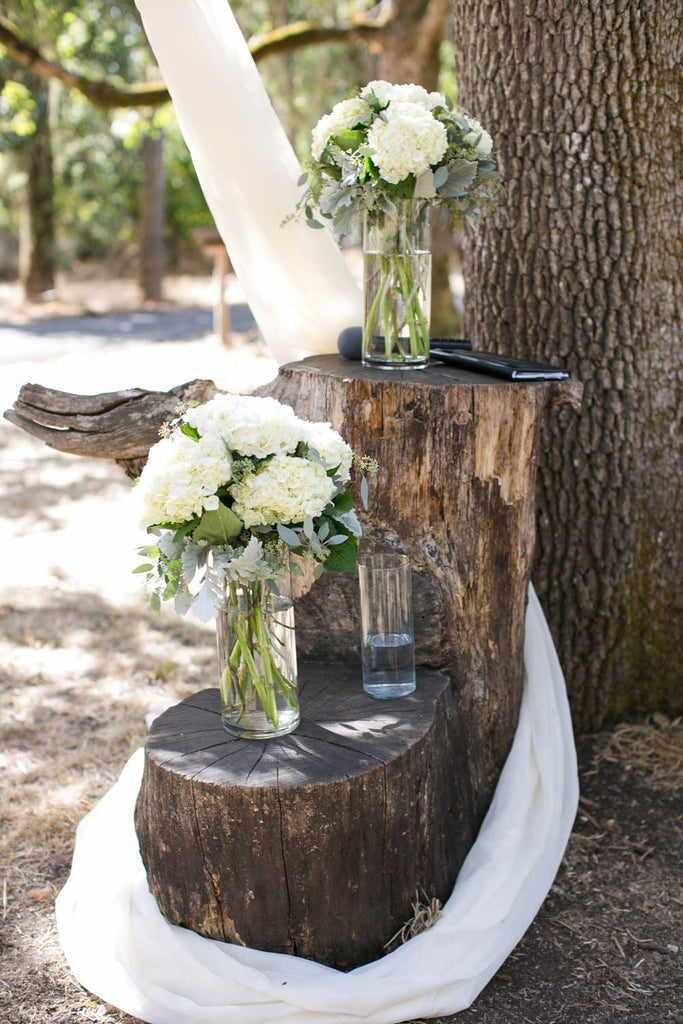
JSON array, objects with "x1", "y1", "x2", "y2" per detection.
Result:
[{"x1": 19, "y1": 73, "x2": 55, "y2": 302}]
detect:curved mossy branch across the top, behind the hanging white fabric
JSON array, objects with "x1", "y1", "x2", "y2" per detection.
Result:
[{"x1": 0, "y1": 14, "x2": 390, "y2": 111}]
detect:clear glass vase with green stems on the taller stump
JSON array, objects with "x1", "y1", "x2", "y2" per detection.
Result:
[{"x1": 362, "y1": 199, "x2": 432, "y2": 370}]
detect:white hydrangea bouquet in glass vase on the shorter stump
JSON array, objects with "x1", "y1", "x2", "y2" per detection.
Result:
[{"x1": 134, "y1": 394, "x2": 374, "y2": 738}]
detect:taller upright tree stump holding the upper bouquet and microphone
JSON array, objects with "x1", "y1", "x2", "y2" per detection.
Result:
[{"x1": 257, "y1": 355, "x2": 581, "y2": 831}]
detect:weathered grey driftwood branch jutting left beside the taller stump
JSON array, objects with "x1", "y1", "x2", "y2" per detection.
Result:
[{"x1": 5, "y1": 380, "x2": 217, "y2": 477}]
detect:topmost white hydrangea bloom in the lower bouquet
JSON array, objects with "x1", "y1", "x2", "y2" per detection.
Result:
[{"x1": 184, "y1": 394, "x2": 303, "y2": 459}]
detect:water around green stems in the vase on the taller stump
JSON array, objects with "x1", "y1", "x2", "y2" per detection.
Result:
[{"x1": 362, "y1": 251, "x2": 432, "y2": 370}]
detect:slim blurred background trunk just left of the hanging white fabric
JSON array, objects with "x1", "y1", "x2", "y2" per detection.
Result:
[{"x1": 139, "y1": 132, "x2": 165, "y2": 302}]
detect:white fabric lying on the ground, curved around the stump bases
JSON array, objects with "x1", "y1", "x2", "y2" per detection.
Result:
[{"x1": 56, "y1": 589, "x2": 579, "y2": 1024}]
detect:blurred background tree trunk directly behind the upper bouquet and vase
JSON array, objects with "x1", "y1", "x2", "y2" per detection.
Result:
[{"x1": 379, "y1": 0, "x2": 460, "y2": 337}]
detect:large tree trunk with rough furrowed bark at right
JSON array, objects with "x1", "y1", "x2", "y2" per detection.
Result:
[{"x1": 453, "y1": 0, "x2": 683, "y2": 729}]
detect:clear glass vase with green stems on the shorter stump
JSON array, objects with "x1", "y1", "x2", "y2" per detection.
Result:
[{"x1": 216, "y1": 563, "x2": 299, "y2": 739}]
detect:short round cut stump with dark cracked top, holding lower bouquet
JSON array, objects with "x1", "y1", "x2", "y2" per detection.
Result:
[{"x1": 136, "y1": 663, "x2": 462, "y2": 970}]
